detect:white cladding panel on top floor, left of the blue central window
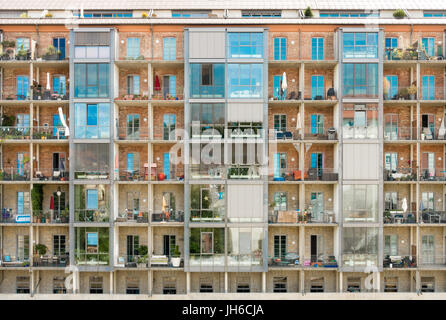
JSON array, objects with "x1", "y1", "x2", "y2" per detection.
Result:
[{"x1": 189, "y1": 31, "x2": 225, "y2": 59}]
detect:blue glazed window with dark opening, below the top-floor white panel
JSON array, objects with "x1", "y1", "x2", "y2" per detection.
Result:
[{"x1": 190, "y1": 63, "x2": 225, "y2": 99}]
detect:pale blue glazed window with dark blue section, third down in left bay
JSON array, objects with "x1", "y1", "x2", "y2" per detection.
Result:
[{"x1": 74, "y1": 103, "x2": 110, "y2": 139}]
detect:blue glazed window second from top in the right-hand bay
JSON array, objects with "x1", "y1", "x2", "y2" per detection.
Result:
[{"x1": 343, "y1": 63, "x2": 378, "y2": 98}]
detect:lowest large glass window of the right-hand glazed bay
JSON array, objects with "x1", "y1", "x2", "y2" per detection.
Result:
[{"x1": 342, "y1": 227, "x2": 378, "y2": 267}]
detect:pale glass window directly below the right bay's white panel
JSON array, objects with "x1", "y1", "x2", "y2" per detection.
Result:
[{"x1": 342, "y1": 184, "x2": 378, "y2": 223}]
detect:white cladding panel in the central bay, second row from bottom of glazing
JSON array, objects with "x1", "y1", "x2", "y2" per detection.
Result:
[{"x1": 227, "y1": 184, "x2": 263, "y2": 222}]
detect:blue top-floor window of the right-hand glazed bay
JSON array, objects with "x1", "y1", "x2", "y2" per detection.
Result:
[{"x1": 343, "y1": 32, "x2": 378, "y2": 59}]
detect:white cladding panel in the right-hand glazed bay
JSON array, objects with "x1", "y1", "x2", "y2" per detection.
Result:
[{"x1": 342, "y1": 143, "x2": 382, "y2": 180}]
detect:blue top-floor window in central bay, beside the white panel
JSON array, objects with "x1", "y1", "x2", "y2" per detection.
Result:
[{"x1": 228, "y1": 32, "x2": 263, "y2": 58}]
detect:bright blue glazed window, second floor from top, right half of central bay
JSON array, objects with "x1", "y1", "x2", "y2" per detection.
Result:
[{"x1": 228, "y1": 64, "x2": 263, "y2": 98}]
